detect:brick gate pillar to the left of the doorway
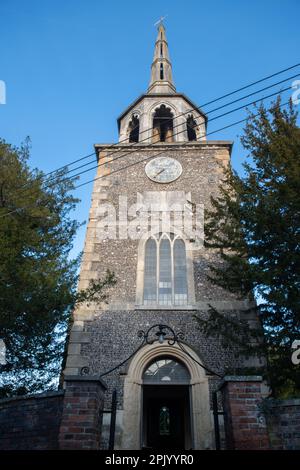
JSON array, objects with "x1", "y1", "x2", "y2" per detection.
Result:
[{"x1": 59, "y1": 375, "x2": 106, "y2": 450}]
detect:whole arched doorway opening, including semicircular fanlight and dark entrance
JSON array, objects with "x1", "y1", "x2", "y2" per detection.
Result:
[{"x1": 142, "y1": 356, "x2": 192, "y2": 450}]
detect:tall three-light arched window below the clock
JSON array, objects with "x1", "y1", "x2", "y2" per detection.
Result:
[{"x1": 144, "y1": 233, "x2": 188, "y2": 305}]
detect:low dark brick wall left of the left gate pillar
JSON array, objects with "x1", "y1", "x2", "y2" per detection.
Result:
[{"x1": 0, "y1": 392, "x2": 64, "y2": 450}]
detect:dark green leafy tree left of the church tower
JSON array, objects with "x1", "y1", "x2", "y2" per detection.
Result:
[{"x1": 0, "y1": 140, "x2": 115, "y2": 397}]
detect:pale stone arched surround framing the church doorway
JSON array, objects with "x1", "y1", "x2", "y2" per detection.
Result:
[{"x1": 120, "y1": 343, "x2": 214, "y2": 450}]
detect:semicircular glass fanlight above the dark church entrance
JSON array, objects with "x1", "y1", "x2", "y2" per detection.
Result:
[{"x1": 143, "y1": 357, "x2": 190, "y2": 385}]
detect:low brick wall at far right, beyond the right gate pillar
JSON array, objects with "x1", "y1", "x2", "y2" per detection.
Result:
[{"x1": 266, "y1": 399, "x2": 300, "y2": 450}]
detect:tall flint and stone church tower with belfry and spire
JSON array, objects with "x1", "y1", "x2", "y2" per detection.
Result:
[{"x1": 61, "y1": 24, "x2": 266, "y2": 449}]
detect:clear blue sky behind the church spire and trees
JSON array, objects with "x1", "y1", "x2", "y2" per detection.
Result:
[{"x1": 0, "y1": 0, "x2": 300, "y2": 258}]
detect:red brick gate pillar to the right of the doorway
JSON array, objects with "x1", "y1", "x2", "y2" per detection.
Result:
[{"x1": 221, "y1": 376, "x2": 270, "y2": 450}]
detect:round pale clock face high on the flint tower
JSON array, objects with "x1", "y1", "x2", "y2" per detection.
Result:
[{"x1": 145, "y1": 157, "x2": 182, "y2": 183}]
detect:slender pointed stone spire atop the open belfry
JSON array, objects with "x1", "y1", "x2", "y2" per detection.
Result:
[{"x1": 148, "y1": 22, "x2": 176, "y2": 94}]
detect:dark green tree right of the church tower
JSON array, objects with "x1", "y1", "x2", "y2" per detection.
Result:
[{"x1": 200, "y1": 98, "x2": 300, "y2": 396}]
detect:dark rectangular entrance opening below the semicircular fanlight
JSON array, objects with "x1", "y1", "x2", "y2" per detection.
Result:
[{"x1": 143, "y1": 385, "x2": 192, "y2": 450}]
